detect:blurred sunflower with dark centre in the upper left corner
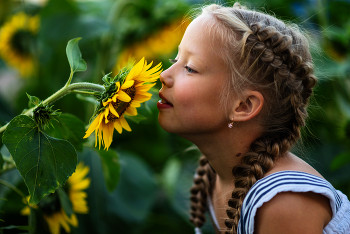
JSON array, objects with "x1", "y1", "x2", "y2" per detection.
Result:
[{"x1": 0, "y1": 12, "x2": 39, "y2": 77}]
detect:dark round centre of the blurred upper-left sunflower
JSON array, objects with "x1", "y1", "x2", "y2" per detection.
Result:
[{"x1": 11, "y1": 30, "x2": 33, "y2": 55}]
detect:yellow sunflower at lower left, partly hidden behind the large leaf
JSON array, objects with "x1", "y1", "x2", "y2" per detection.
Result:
[{"x1": 21, "y1": 162, "x2": 90, "y2": 234}]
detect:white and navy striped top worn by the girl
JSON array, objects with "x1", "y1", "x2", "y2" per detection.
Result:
[{"x1": 208, "y1": 171, "x2": 350, "y2": 234}]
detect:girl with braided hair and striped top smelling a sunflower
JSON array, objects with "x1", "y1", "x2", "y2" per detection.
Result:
[{"x1": 158, "y1": 4, "x2": 350, "y2": 234}]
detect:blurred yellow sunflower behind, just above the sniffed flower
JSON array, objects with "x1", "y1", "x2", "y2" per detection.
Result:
[{"x1": 114, "y1": 19, "x2": 190, "y2": 69}]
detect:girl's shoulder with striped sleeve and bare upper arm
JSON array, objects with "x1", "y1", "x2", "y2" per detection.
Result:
[{"x1": 238, "y1": 170, "x2": 350, "y2": 234}]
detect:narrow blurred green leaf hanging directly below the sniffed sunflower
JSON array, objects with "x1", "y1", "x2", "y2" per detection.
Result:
[{"x1": 94, "y1": 148, "x2": 120, "y2": 192}]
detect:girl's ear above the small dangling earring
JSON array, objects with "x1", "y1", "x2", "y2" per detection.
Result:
[{"x1": 229, "y1": 90, "x2": 264, "y2": 122}]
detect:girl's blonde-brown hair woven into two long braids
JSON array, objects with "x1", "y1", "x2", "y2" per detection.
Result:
[{"x1": 190, "y1": 3, "x2": 317, "y2": 234}]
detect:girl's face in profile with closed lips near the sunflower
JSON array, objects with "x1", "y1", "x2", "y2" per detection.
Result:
[{"x1": 157, "y1": 16, "x2": 229, "y2": 137}]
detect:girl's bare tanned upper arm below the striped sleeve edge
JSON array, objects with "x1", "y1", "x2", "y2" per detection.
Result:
[{"x1": 254, "y1": 192, "x2": 332, "y2": 234}]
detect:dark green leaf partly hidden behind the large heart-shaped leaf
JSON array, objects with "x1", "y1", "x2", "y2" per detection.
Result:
[{"x1": 46, "y1": 113, "x2": 85, "y2": 151}]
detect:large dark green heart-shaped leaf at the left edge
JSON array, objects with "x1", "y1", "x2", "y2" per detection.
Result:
[{"x1": 3, "y1": 115, "x2": 77, "y2": 206}]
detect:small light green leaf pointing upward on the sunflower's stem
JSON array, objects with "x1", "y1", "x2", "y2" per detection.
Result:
[{"x1": 66, "y1": 37, "x2": 87, "y2": 73}]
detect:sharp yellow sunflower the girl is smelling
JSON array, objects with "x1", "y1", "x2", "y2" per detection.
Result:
[{"x1": 84, "y1": 58, "x2": 161, "y2": 150}]
